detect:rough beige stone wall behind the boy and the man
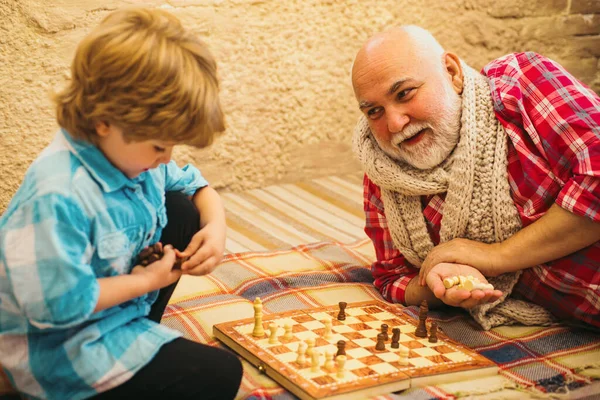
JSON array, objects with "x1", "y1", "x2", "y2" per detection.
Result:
[{"x1": 0, "y1": 0, "x2": 600, "y2": 212}]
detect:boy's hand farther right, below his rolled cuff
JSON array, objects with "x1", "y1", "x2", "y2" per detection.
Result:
[{"x1": 178, "y1": 223, "x2": 225, "y2": 276}]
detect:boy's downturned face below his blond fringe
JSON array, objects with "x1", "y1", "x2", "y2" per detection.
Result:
[{"x1": 96, "y1": 122, "x2": 174, "y2": 178}]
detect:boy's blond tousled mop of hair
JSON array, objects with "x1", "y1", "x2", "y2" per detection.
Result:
[{"x1": 54, "y1": 8, "x2": 225, "y2": 147}]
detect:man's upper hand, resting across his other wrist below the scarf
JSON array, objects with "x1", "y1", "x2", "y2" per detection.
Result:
[{"x1": 419, "y1": 239, "x2": 502, "y2": 286}]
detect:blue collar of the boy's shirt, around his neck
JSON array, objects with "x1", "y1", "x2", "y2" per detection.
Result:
[{"x1": 60, "y1": 128, "x2": 147, "y2": 193}]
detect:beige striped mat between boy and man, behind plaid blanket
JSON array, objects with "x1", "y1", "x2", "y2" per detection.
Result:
[{"x1": 221, "y1": 173, "x2": 366, "y2": 253}]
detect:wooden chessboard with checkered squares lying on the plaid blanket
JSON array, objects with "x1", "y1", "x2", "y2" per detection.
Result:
[{"x1": 213, "y1": 299, "x2": 498, "y2": 400}]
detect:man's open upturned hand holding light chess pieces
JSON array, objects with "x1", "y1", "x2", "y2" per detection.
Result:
[{"x1": 426, "y1": 263, "x2": 502, "y2": 308}]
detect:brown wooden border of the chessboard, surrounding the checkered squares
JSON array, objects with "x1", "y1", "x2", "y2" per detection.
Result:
[{"x1": 213, "y1": 300, "x2": 498, "y2": 400}]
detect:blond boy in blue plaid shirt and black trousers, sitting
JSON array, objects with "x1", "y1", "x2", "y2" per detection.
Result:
[{"x1": 0, "y1": 9, "x2": 242, "y2": 400}]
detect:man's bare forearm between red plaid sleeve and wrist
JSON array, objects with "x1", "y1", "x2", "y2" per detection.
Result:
[{"x1": 495, "y1": 204, "x2": 600, "y2": 275}]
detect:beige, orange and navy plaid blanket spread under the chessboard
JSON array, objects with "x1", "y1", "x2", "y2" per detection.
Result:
[{"x1": 163, "y1": 240, "x2": 600, "y2": 400}]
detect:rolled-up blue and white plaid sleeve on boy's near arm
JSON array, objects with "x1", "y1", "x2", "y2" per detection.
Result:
[{"x1": 0, "y1": 194, "x2": 99, "y2": 329}]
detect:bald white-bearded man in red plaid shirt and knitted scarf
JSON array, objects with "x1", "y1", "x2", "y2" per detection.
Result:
[{"x1": 352, "y1": 26, "x2": 600, "y2": 329}]
